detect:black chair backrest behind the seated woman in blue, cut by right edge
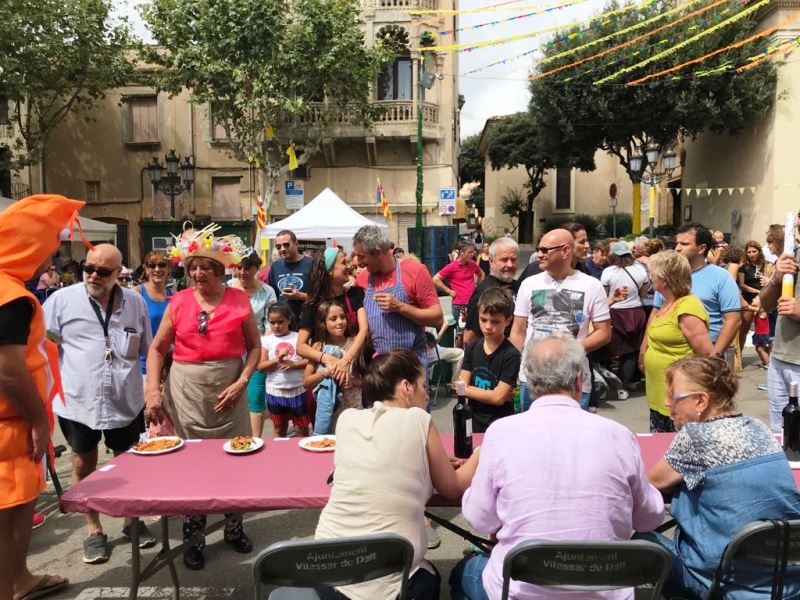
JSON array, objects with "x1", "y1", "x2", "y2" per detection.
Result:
[{"x1": 706, "y1": 519, "x2": 800, "y2": 599}]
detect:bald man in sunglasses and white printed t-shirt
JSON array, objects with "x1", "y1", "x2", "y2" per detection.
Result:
[{"x1": 509, "y1": 229, "x2": 611, "y2": 410}]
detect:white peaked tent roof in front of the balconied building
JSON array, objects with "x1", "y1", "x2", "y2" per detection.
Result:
[{"x1": 264, "y1": 188, "x2": 387, "y2": 240}]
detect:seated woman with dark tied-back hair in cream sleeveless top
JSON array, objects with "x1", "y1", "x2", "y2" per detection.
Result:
[{"x1": 315, "y1": 349, "x2": 479, "y2": 600}]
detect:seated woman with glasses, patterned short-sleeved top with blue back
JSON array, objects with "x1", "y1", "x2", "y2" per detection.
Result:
[{"x1": 641, "y1": 356, "x2": 800, "y2": 598}]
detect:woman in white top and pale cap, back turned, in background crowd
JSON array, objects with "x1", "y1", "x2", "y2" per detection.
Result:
[{"x1": 600, "y1": 242, "x2": 647, "y2": 400}]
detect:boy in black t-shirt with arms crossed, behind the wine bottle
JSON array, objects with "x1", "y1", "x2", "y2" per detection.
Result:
[{"x1": 461, "y1": 288, "x2": 520, "y2": 433}]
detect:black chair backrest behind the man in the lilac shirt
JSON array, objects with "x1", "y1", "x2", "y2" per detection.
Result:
[{"x1": 502, "y1": 540, "x2": 670, "y2": 600}]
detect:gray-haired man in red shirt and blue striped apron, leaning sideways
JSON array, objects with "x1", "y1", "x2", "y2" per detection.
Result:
[{"x1": 353, "y1": 225, "x2": 443, "y2": 370}]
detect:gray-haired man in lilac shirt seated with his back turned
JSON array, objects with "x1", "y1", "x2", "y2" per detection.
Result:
[{"x1": 450, "y1": 333, "x2": 664, "y2": 600}]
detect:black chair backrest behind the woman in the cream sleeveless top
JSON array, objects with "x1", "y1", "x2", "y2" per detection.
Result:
[{"x1": 253, "y1": 533, "x2": 414, "y2": 600}]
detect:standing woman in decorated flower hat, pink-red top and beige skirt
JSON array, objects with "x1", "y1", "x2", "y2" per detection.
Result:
[{"x1": 145, "y1": 224, "x2": 261, "y2": 570}]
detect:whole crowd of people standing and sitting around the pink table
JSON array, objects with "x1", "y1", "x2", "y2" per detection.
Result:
[{"x1": 0, "y1": 196, "x2": 800, "y2": 600}]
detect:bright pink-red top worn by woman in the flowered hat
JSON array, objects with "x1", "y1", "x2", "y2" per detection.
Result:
[{"x1": 169, "y1": 286, "x2": 253, "y2": 362}]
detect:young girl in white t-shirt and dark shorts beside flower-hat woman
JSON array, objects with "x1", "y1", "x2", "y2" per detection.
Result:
[{"x1": 258, "y1": 303, "x2": 311, "y2": 437}]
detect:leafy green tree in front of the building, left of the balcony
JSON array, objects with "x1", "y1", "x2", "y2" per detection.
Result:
[{"x1": 142, "y1": 0, "x2": 393, "y2": 204}]
